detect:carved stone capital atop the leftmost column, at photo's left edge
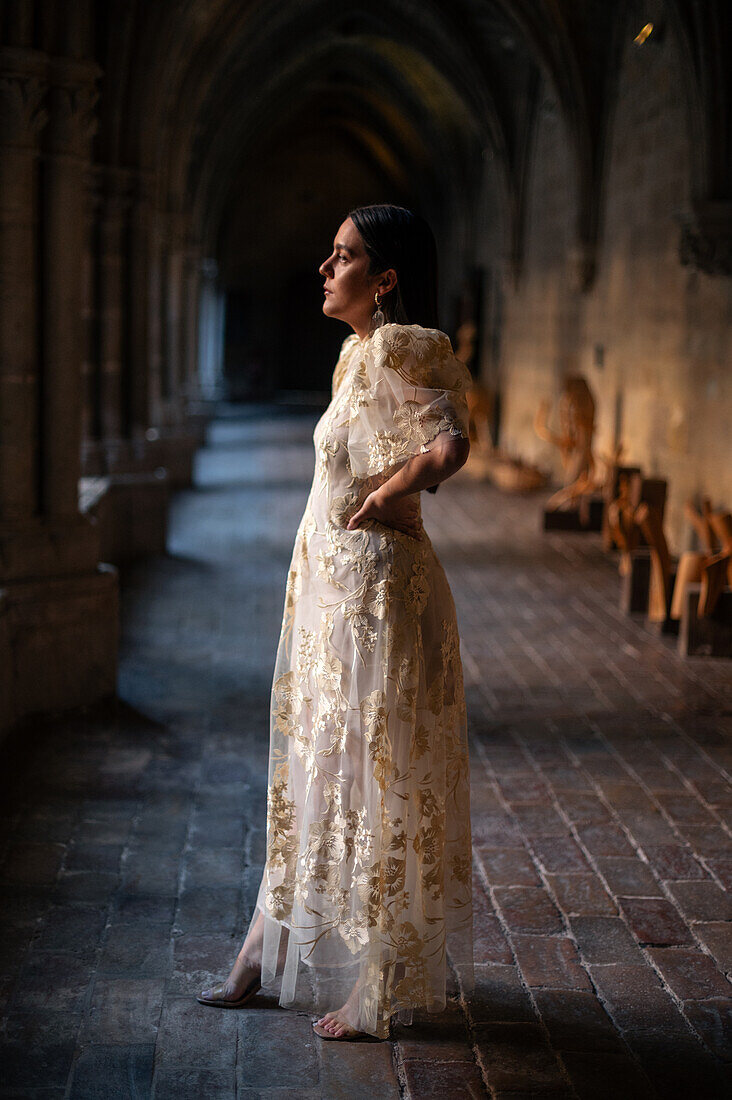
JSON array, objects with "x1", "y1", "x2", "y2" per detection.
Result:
[{"x1": 0, "y1": 46, "x2": 48, "y2": 149}]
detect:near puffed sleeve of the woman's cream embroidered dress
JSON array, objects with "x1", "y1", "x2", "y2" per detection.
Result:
[{"x1": 348, "y1": 323, "x2": 472, "y2": 480}]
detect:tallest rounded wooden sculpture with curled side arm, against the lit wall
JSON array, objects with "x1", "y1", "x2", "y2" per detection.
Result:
[{"x1": 534, "y1": 374, "x2": 597, "y2": 512}]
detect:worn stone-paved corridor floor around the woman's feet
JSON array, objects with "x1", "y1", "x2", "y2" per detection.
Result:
[{"x1": 0, "y1": 408, "x2": 732, "y2": 1100}]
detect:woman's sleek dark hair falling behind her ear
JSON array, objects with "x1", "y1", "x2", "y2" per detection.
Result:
[{"x1": 347, "y1": 204, "x2": 439, "y2": 329}]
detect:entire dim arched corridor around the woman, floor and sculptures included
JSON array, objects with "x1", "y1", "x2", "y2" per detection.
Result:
[{"x1": 0, "y1": 0, "x2": 732, "y2": 1100}]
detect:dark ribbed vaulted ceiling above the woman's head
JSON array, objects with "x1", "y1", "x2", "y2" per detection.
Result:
[{"x1": 94, "y1": 0, "x2": 623, "y2": 285}]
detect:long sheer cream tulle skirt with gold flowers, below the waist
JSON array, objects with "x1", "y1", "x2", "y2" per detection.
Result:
[{"x1": 250, "y1": 512, "x2": 473, "y2": 1038}]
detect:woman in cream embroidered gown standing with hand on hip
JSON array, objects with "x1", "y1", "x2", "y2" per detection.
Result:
[{"x1": 198, "y1": 206, "x2": 472, "y2": 1038}]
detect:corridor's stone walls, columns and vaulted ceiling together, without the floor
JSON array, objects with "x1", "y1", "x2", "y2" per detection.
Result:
[{"x1": 0, "y1": 0, "x2": 732, "y2": 728}]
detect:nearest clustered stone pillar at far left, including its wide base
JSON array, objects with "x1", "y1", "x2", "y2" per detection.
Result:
[{"x1": 0, "y1": 48, "x2": 119, "y2": 729}]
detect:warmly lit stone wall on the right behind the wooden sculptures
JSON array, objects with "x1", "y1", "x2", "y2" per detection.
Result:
[{"x1": 493, "y1": 13, "x2": 732, "y2": 551}]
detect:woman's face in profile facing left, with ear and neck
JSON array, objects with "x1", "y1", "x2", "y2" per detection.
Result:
[{"x1": 318, "y1": 218, "x2": 396, "y2": 337}]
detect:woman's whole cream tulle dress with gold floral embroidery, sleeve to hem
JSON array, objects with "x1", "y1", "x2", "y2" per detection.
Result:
[{"x1": 263, "y1": 325, "x2": 471, "y2": 1037}]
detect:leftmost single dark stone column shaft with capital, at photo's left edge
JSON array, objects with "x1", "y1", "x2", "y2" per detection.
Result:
[{"x1": 0, "y1": 48, "x2": 47, "y2": 532}]
